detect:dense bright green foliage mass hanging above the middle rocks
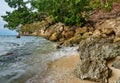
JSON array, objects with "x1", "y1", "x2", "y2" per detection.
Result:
[{"x1": 31, "y1": 0, "x2": 91, "y2": 26}]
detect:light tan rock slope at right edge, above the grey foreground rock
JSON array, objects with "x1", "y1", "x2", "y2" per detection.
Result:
[{"x1": 98, "y1": 17, "x2": 120, "y2": 42}]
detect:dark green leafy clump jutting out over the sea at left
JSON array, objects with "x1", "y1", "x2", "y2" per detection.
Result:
[{"x1": 2, "y1": 7, "x2": 34, "y2": 29}]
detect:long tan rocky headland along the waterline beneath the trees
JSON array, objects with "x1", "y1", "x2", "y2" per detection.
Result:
[{"x1": 21, "y1": 17, "x2": 93, "y2": 46}]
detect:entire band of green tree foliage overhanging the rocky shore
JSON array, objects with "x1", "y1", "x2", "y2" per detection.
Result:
[{"x1": 2, "y1": 0, "x2": 114, "y2": 29}]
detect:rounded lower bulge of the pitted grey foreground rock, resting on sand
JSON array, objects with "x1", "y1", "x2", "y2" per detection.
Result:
[{"x1": 75, "y1": 57, "x2": 111, "y2": 83}]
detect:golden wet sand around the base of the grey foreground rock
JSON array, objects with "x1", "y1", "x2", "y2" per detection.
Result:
[{"x1": 39, "y1": 54, "x2": 120, "y2": 83}]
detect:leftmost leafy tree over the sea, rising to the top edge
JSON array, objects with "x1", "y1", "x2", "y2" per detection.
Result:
[{"x1": 2, "y1": 0, "x2": 36, "y2": 30}]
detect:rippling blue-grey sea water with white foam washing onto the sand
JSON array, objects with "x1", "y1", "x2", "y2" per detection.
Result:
[{"x1": 0, "y1": 36, "x2": 77, "y2": 83}]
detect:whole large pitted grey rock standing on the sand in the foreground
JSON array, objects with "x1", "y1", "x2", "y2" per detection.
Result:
[{"x1": 75, "y1": 36, "x2": 120, "y2": 83}]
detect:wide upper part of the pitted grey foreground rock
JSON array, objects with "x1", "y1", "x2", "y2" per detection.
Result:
[{"x1": 79, "y1": 37, "x2": 120, "y2": 60}]
